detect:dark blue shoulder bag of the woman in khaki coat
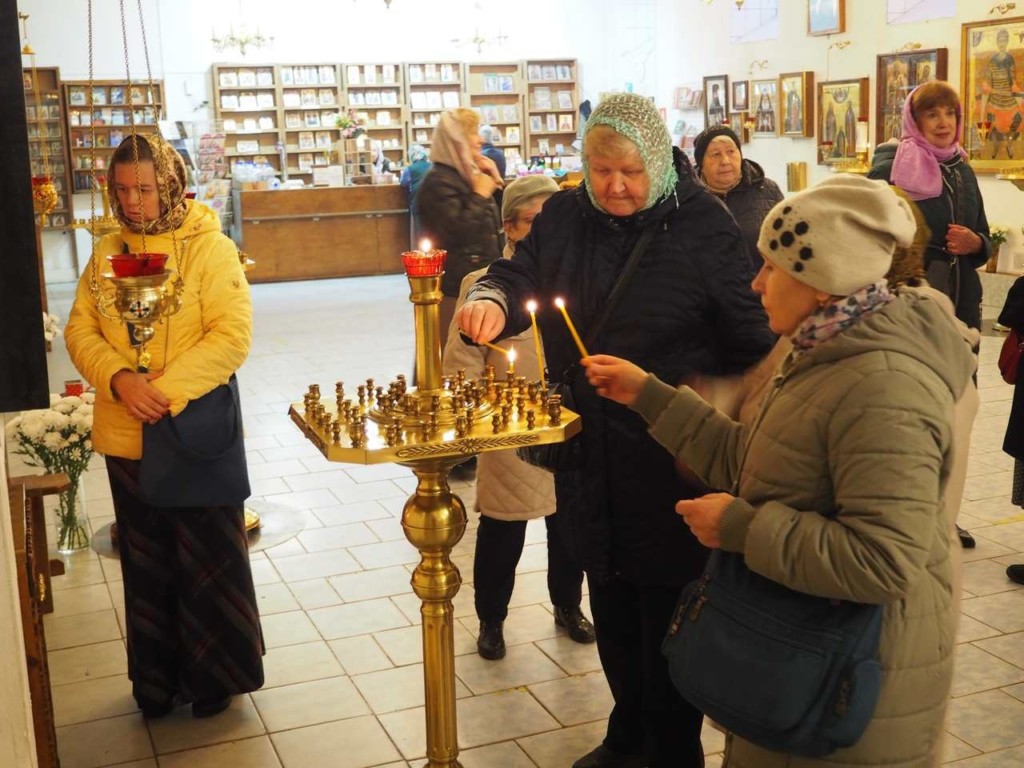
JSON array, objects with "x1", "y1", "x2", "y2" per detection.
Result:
[{"x1": 662, "y1": 551, "x2": 882, "y2": 757}]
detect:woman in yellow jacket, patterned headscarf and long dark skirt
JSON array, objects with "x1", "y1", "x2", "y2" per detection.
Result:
[{"x1": 66, "y1": 135, "x2": 264, "y2": 718}]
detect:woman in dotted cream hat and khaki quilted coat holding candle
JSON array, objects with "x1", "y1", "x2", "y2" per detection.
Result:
[{"x1": 584, "y1": 174, "x2": 975, "y2": 768}]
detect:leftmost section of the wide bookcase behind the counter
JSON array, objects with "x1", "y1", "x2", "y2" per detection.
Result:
[{"x1": 211, "y1": 63, "x2": 282, "y2": 179}]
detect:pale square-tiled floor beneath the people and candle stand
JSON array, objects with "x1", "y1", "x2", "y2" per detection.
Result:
[{"x1": 11, "y1": 276, "x2": 1024, "y2": 768}]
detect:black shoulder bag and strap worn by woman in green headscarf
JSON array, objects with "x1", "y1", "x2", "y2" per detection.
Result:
[{"x1": 515, "y1": 219, "x2": 662, "y2": 472}]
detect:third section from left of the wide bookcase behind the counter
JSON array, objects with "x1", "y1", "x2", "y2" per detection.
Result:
[{"x1": 341, "y1": 63, "x2": 409, "y2": 167}]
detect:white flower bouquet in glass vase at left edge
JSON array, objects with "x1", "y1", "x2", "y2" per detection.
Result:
[{"x1": 6, "y1": 392, "x2": 95, "y2": 552}]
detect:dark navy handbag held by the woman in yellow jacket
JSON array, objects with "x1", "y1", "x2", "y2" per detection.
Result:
[{"x1": 138, "y1": 374, "x2": 250, "y2": 507}]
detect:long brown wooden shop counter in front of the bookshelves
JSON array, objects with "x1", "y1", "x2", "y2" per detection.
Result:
[{"x1": 232, "y1": 184, "x2": 410, "y2": 283}]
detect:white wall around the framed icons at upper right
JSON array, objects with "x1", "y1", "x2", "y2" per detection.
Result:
[{"x1": 663, "y1": 0, "x2": 1024, "y2": 269}]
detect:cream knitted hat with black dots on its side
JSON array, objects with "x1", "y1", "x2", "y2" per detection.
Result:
[{"x1": 758, "y1": 173, "x2": 916, "y2": 296}]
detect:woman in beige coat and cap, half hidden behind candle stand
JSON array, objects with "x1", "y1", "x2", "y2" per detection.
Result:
[{"x1": 443, "y1": 176, "x2": 594, "y2": 660}]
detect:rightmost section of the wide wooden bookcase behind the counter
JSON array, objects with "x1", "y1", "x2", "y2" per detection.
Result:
[{"x1": 524, "y1": 58, "x2": 580, "y2": 162}]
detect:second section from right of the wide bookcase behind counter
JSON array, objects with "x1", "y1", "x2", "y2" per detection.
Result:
[{"x1": 465, "y1": 61, "x2": 528, "y2": 172}]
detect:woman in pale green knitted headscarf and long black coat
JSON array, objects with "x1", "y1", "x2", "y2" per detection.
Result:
[{"x1": 457, "y1": 93, "x2": 774, "y2": 768}]
